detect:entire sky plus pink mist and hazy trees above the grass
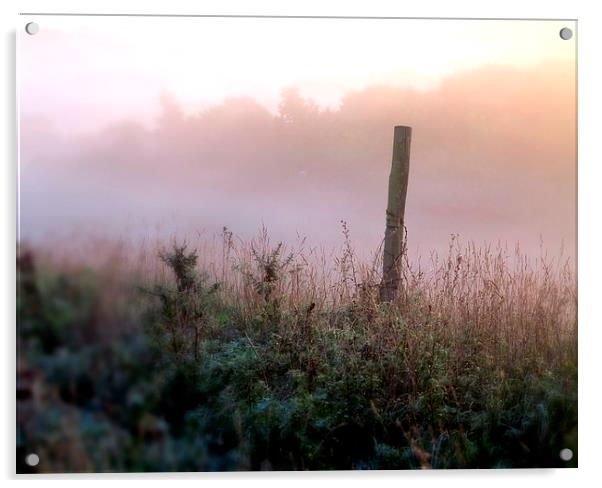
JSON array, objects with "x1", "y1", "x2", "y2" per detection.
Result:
[{"x1": 17, "y1": 17, "x2": 576, "y2": 264}]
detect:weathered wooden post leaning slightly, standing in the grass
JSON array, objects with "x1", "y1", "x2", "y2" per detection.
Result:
[{"x1": 380, "y1": 125, "x2": 412, "y2": 302}]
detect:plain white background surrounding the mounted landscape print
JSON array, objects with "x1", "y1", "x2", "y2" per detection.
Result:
[{"x1": 0, "y1": 0, "x2": 602, "y2": 488}]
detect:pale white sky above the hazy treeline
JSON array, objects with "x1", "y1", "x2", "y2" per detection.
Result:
[{"x1": 19, "y1": 17, "x2": 575, "y2": 131}]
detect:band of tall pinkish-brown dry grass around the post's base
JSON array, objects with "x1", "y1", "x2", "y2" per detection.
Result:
[{"x1": 24, "y1": 222, "x2": 577, "y2": 367}]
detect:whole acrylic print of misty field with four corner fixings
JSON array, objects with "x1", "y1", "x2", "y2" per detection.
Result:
[{"x1": 16, "y1": 15, "x2": 577, "y2": 473}]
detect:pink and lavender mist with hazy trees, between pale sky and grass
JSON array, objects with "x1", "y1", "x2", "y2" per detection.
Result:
[{"x1": 20, "y1": 64, "x2": 576, "y2": 264}]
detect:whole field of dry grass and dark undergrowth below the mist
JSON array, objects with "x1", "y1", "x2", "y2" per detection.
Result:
[{"x1": 17, "y1": 229, "x2": 577, "y2": 472}]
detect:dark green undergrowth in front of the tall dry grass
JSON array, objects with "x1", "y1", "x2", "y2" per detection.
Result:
[{"x1": 17, "y1": 246, "x2": 577, "y2": 471}]
